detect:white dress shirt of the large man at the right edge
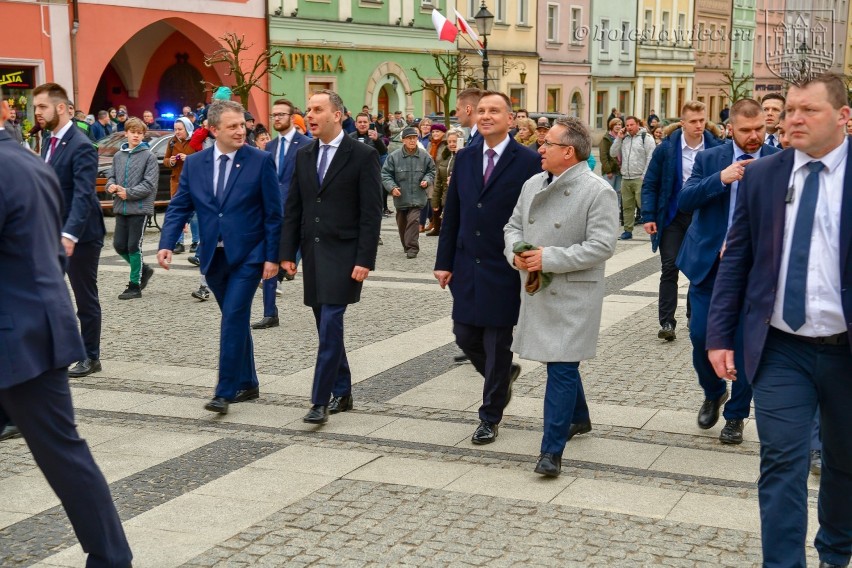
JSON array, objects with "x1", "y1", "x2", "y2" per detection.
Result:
[{"x1": 771, "y1": 142, "x2": 847, "y2": 337}]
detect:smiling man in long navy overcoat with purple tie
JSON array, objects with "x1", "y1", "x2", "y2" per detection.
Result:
[{"x1": 435, "y1": 91, "x2": 541, "y2": 444}]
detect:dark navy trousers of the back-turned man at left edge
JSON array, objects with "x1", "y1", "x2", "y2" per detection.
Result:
[{"x1": 0, "y1": 368, "x2": 133, "y2": 568}]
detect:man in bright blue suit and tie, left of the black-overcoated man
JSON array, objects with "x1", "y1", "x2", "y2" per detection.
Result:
[{"x1": 157, "y1": 101, "x2": 282, "y2": 414}]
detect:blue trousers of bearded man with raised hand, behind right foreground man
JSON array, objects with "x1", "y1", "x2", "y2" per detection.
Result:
[{"x1": 689, "y1": 277, "x2": 751, "y2": 420}]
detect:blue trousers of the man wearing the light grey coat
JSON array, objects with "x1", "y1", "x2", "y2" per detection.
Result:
[{"x1": 541, "y1": 363, "x2": 589, "y2": 456}]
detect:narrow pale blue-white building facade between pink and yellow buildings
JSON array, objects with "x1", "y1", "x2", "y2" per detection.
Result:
[{"x1": 588, "y1": 0, "x2": 638, "y2": 130}]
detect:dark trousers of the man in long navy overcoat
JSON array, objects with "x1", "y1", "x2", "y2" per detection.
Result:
[{"x1": 453, "y1": 322, "x2": 512, "y2": 424}]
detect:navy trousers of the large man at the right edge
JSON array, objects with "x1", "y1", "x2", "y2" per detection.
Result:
[{"x1": 752, "y1": 329, "x2": 852, "y2": 568}]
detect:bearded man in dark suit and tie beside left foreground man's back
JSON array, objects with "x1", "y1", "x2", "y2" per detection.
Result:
[{"x1": 33, "y1": 83, "x2": 106, "y2": 377}]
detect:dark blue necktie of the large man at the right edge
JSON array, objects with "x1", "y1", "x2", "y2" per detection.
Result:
[{"x1": 783, "y1": 162, "x2": 825, "y2": 331}]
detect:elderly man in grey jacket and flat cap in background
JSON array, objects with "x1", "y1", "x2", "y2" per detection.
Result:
[{"x1": 382, "y1": 126, "x2": 435, "y2": 259}]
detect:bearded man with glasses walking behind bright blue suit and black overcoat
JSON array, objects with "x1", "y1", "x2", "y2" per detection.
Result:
[{"x1": 251, "y1": 99, "x2": 311, "y2": 329}]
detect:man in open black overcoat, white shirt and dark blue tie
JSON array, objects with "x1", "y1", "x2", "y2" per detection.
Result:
[{"x1": 280, "y1": 90, "x2": 382, "y2": 424}]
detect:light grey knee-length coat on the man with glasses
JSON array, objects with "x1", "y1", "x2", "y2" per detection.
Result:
[{"x1": 504, "y1": 162, "x2": 619, "y2": 362}]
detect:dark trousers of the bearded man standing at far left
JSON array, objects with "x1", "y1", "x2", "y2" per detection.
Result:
[{"x1": 67, "y1": 239, "x2": 104, "y2": 359}]
